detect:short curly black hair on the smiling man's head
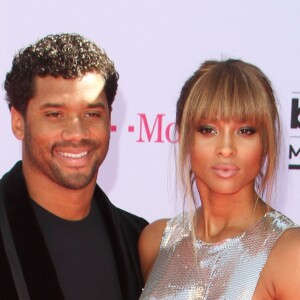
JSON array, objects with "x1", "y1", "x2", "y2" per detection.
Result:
[{"x1": 4, "y1": 33, "x2": 119, "y2": 115}]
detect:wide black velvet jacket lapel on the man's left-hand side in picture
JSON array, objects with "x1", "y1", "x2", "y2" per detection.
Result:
[{"x1": 2, "y1": 162, "x2": 64, "y2": 300}]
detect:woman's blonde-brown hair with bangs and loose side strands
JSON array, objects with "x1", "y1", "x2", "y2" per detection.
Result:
[{"x1": 176, "y1": 59, "x2": 281, "y2": 208}]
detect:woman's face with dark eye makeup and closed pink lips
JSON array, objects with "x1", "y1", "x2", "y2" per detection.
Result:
[{"x1": 190, "y1": 120, "x2": 263, "y2": 195}]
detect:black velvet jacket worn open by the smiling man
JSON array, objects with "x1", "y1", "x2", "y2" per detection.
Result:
[{"x1": 0, "y1": 162, "x2": 147, "y2": 300}]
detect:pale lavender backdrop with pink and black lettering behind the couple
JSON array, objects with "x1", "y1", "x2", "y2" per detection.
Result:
[{"x1": 0, "y1": 0, "x2": 300, "y2": 223}]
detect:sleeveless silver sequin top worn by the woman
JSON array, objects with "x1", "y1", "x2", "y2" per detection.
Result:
[{"x1": 140, "y1": 211, "x2": 297, "y2": 300}]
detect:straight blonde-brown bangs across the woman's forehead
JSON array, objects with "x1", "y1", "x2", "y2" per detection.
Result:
[{"x1": 187, "y1": 61, "x2": 268, "y2": 126}]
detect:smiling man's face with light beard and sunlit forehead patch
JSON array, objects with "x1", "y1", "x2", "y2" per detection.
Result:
[{"x1": 12, "y1": 73, "x2": 110, "y2": 189}]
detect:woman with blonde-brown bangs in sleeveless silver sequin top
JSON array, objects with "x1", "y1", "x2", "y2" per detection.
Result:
[{"x1": 139, "y1": 59, "x2": 300, "y2": 300}]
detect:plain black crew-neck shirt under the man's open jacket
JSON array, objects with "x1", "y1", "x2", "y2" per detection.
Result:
[{"x1": 32, "y1": 201, "x2": 121, "y2": 300}]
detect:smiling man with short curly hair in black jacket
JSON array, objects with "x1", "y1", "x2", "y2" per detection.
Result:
[{"x1": 0, "y1": 34, "x2": 147, "y2": 300}]
